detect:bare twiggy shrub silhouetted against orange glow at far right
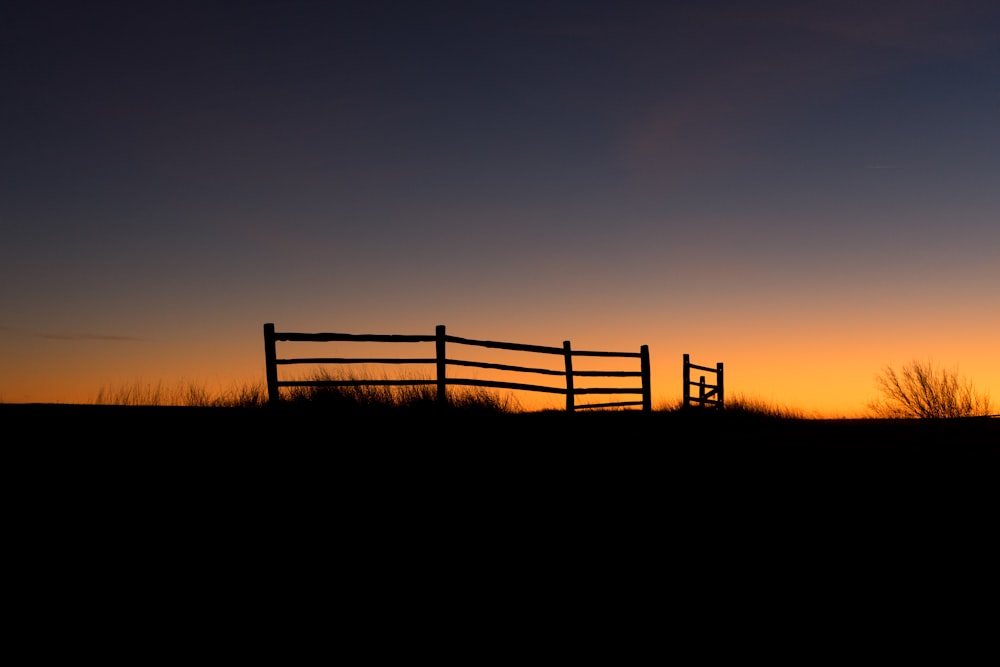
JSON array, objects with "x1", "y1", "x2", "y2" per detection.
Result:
[{"x1": 868, "y1": 361, "x2": 992, "y2": 419}]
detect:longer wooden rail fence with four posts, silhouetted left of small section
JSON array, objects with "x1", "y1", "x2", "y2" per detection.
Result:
[{"x1": 264, "y1": 323, "x2": 652, "y2": 412}]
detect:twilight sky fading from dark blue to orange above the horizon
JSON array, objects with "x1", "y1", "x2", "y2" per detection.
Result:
[{"x1": 0, "y1": 0, "x2": 1000, "y2": 416}]
